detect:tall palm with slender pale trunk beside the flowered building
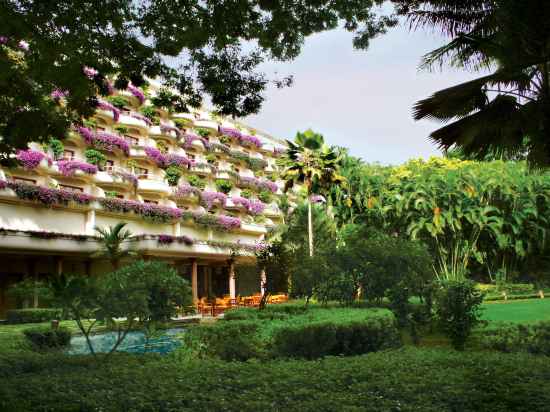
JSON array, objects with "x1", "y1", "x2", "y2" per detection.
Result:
[{"x1": 279, "y1": 129, "x2": 344, "y2": 256}]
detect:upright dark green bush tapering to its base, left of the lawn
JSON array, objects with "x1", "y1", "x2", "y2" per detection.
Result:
[{"x1": 436, "y1": 280, "x2": 483, "y2": 350}]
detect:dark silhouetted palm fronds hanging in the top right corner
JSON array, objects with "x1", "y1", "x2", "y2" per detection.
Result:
[{"x1": 393, "y1": 0, "x2": 550, "y2": 166}]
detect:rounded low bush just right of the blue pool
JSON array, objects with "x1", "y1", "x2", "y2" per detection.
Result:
[{"x1": 183, "y1": 321, "x2": 261, "y2": 361}]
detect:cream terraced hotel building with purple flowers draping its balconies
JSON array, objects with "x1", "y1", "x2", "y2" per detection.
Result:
[{"x1": 0, "y1": 83, "x2": 285, "y2": 319}]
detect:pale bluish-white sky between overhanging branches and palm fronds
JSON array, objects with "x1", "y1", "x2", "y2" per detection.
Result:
[{"x1": 243, "y1": 26, "x2": 486, "y2": 164}]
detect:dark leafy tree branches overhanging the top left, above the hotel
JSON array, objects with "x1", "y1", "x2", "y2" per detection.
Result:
[{"x1": 0, "y1": 0, "x2": 396, "y2": 160}]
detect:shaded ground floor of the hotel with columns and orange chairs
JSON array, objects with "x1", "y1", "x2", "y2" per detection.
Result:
[{"x1": 0, "y1": 234, "x2": 284, "y2": 319}]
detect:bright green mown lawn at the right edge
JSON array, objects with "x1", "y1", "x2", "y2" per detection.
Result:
[{"x1": 482, "y1": 299, "x2": 550, "y2": 323}]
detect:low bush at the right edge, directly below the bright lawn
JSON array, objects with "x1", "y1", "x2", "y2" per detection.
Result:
[{"x1": 481, "y1": 322, "x2": 550, "y2": 356}]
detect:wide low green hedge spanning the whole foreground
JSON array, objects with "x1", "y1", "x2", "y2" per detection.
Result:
[{"x1": 0, "y1": 348, "x2": 550, "y2": 412}]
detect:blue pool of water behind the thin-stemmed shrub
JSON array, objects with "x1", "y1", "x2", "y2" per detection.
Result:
[{"x1": 67, "y1": 328, "x2": 185, "y2": 355}]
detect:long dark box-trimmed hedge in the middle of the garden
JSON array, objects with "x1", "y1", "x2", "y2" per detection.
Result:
[{"x1": 272, "y1": 317, "x2": 401, "y2": 359}]
